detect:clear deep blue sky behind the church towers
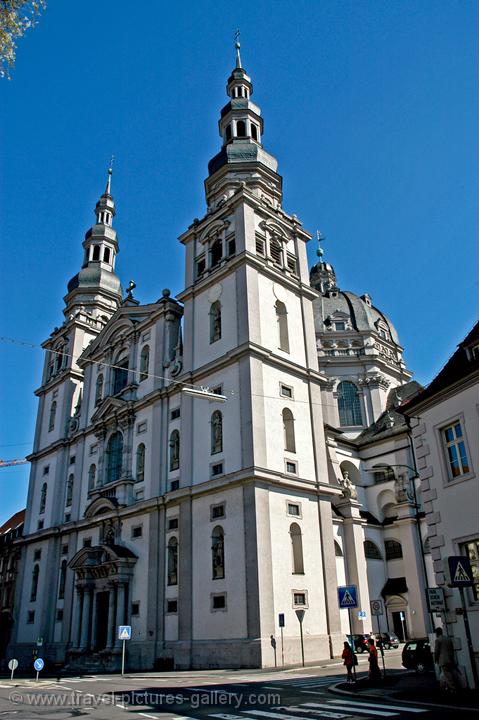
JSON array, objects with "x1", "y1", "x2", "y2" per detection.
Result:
[{"x1": 0, "y1": 0, "x2": 479, "y2": 522}]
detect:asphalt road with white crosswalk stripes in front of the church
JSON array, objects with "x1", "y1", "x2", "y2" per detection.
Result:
[{"x1": 0, "y1": 650, "x2": 466, "y2": 720}]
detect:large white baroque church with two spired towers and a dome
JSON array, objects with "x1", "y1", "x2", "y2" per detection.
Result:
[{"x1": 10, "y1": 46, "x2": 436, "y2": 669}]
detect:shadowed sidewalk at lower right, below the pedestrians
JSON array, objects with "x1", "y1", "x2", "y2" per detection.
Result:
[{"x1": 329, "y1": 670, "x2": 479, "y2": 712}]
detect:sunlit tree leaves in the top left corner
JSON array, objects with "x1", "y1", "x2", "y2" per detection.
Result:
[{"x1": 0, "y1": 0, "x2": 47, "y2": 79}]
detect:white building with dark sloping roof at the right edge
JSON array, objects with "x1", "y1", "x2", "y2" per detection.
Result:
[{"x1": 404, "y1": 323, "x2": 479, "y2": 685}]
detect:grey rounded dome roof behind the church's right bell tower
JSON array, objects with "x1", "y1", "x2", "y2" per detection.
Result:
[{"x1": 311, "y1": 262, "x2": 400, "y2": 345}]
